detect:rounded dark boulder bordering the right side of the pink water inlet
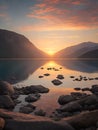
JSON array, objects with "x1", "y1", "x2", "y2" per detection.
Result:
[{"x1": 58, "y1": 95, "x2": 75, "y2": 105}]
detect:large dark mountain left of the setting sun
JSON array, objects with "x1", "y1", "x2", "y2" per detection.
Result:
[{"x1": 0, "y1": 29, "x2": 48, "y2": 58}]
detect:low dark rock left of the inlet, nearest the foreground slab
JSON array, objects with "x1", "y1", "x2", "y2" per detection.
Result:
[{"x1": 19, "y1": 104, "x2": 36, "y2": 114}]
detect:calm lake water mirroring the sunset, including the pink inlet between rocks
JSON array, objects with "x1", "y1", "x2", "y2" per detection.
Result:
[{"x1": 0, "y1": 60, "x2": 98, "y2": 114}]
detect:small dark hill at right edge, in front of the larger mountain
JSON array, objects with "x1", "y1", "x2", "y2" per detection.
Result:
[{"x1": 80, "y1": 49, "x2": 98, "y2": 58}]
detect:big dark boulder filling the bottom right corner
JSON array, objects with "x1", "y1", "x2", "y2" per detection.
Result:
[{"x1": 65, "y1": 110, "x2": 98, "y2": 130}]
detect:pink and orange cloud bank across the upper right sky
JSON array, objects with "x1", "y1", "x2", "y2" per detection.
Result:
[{"x1": 23, "y1": 0, "x2": 98, "y2": 31}]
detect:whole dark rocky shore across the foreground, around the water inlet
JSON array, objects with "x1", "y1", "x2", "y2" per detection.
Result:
[{"x1": 0, "y1": 80, "x2": 98, "y2": 130}]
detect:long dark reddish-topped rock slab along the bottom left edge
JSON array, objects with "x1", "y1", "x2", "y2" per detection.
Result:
[{"x1": 0, "y1": 109, "x2": 74, "y2": 130}]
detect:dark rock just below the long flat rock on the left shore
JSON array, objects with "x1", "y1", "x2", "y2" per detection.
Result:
[{"x1": 25, "y1": 93, "x2": 40, "y2": 102}]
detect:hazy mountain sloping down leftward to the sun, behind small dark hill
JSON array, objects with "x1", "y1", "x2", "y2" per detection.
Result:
[{"x1": 54, "y1": 42, "x2": 98, "y2": 58}]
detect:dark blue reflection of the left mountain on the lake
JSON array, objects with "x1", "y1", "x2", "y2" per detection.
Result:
[{"x1": 0, "y1": 60, "x2": 46, "y2": 83}]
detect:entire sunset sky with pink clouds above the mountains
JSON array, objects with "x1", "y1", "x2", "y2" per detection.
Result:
[{"x1": 0, "y1": 0, "x2": 98, "y2": 54}]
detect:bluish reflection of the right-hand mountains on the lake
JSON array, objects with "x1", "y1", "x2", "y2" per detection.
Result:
[{"x1": 56, "y1": 60, "x2": 98, "y2": 73}]
